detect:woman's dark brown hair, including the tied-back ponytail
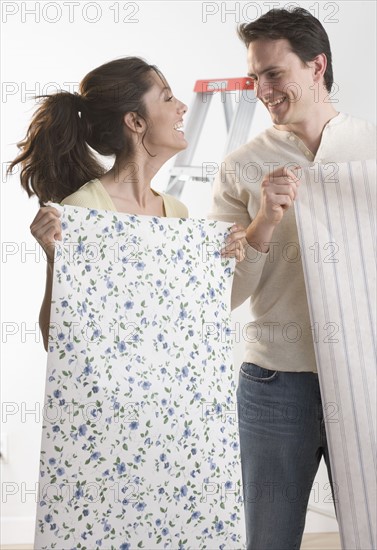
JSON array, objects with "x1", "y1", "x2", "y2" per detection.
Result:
[{"x1": 8, "y1": 57, "x2": 163, "y2": 204}]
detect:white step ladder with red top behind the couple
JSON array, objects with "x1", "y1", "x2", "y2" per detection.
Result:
[{"x1": 165, "y1": 77, "x2": 257, "y2": 198}]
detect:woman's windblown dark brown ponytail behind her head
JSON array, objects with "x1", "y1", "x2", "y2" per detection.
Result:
[{"x1": 8, "y1": 92, "x2": 104, "y2": 204}]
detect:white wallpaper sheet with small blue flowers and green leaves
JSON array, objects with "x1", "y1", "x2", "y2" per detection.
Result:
[{"x1": 35, "y1": 205, "x2": 244, "y2": 550}]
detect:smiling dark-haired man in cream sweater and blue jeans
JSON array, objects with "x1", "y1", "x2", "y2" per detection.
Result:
[{"x1": 211, "y1": 8, "x2": 375, "y2": 550}]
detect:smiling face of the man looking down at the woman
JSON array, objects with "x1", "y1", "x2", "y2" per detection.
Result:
[{"x1": 248, "y1": 39, "x2": 317, "y2": 125}]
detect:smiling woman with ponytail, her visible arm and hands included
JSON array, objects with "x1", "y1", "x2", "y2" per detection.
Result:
[{"x1": 9, "y1": 57, "x2": 245, "y2": 350}]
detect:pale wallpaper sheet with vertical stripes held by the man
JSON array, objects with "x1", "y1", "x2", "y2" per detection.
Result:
[{"x1": 295, "y1": 160, "x2": 377, "y2": 550}]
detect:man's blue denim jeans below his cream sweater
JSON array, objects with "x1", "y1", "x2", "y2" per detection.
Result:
[{"x1": 237, "y1": 363, "x2": 332, "y2": 550}]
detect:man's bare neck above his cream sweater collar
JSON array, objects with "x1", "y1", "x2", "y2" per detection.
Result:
[{"x1": 275, "y1": 105, "x2": 339, "y2": 155}]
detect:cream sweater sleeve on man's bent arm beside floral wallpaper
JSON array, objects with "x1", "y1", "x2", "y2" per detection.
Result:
[{"x1": 207, "y1": 157, "x2": 268, "y2": 309}]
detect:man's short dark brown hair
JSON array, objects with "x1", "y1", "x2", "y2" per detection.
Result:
[{"x1": 238, "y1": 7, "x2": 334, "y2": 92}]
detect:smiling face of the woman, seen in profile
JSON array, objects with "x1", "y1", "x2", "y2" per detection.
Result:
[{"x1": 140, "y1": 71, "x2": 187, "y2": 158}]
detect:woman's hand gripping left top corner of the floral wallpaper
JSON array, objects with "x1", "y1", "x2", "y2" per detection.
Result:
[{"x1": 30, "y1": 206, "x2": 62, "y2": 262}]
